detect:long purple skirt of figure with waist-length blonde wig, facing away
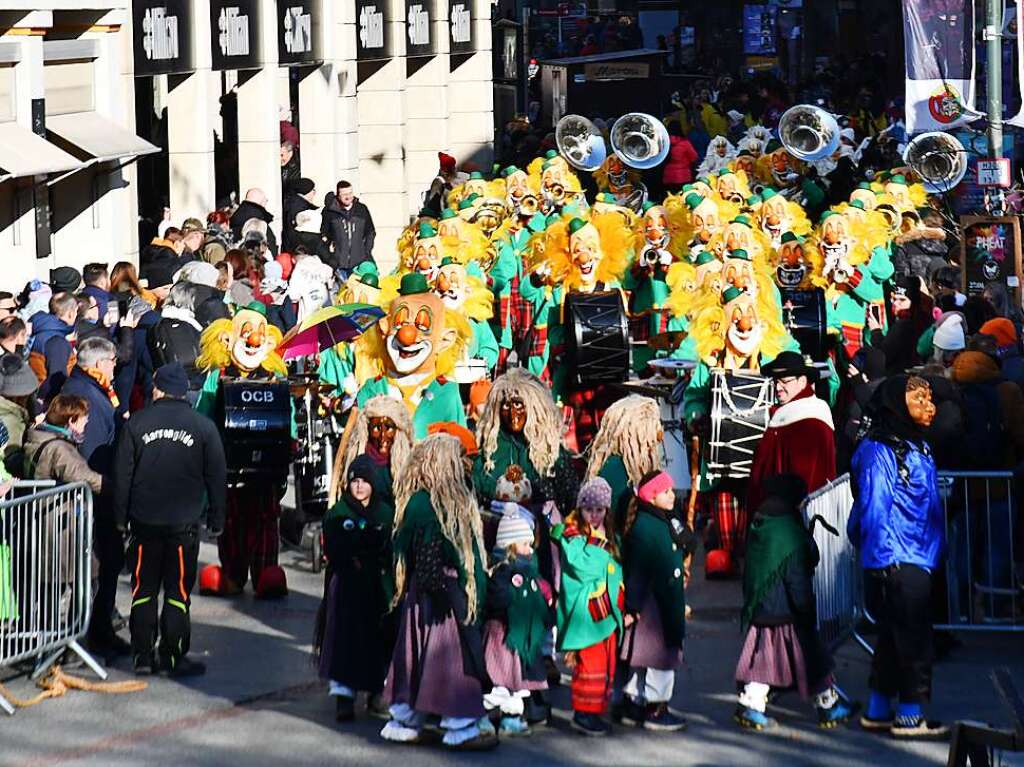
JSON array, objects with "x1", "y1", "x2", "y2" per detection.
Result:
[{"x1": 384, "y1": 576, "x2": 485, "y2": 719}]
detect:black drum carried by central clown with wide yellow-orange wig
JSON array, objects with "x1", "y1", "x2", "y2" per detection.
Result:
[{"x1": 564, "y1": 291, "x2": 630, "y2": 388}]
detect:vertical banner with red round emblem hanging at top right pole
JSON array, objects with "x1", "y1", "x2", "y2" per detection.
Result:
[{"x1": 903, "y1": 0, "x2": 981, "y2": 134}]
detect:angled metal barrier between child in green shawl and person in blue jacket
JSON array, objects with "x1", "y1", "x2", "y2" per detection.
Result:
[{"x1": 804, "y1": 474, "x2": 866, "y2": 649}]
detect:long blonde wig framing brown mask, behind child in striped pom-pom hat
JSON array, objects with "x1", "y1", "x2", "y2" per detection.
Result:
[{"x1": 476, "y1": 368, "x2": 564, "y2": 476}]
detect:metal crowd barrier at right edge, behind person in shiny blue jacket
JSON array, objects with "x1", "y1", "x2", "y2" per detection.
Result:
[{"x1": 936, "y1": 471, "x2": 1024, "y2": 631}]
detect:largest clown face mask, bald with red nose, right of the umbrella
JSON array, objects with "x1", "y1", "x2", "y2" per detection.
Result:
[{"x1": 378, "y1": 293, "x2": 457, "y2": 378}]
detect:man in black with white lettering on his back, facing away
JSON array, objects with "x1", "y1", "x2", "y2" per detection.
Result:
[{"x1": 114, "y1": 363, "x2": 227, "y2": 677}]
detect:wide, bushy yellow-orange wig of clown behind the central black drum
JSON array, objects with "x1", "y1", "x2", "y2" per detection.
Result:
[{"x1": 530, "y1": 213, "x2": 635, "y2": 292}]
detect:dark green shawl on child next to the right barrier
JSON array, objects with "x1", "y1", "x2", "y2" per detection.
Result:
[{"x1": 740, "y1": 499, "x2": 817, "y2": 631}]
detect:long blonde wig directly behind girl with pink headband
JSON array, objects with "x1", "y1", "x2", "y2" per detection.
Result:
[{"x1": 587, "y1": 394, "x2": 665, "y2": 483}]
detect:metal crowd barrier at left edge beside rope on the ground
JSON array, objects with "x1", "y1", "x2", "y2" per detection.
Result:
[{"x1": 0, "y1": 482, "x2": 106, "y2": 714}]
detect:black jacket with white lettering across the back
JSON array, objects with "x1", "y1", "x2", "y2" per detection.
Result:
[{"x1": 114, "y1": 398, "x2": 227, "y2": 530}]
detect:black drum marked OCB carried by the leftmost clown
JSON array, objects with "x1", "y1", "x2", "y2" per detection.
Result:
[{"x1": 214, "y1": 379, "x2": 292, "y2": 481}]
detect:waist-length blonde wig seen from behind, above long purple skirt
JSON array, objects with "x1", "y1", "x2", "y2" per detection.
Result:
[{"x1": 394, "y1": 434, "x2": 484, "y2": 625}]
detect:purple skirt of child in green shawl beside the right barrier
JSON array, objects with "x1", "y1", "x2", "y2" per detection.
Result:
[{"x1": 736, "y1": 624, "x2": 831, "y2": 698}]
